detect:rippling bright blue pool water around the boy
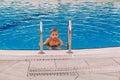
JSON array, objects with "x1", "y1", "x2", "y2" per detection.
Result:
[{"x1": 0, "y1": 0, "x2": 120, "y2": 50}]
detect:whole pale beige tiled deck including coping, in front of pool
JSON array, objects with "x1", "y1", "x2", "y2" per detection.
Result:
[{"x1": 0, "y1": 47, "x2": 120, "y2": 80}]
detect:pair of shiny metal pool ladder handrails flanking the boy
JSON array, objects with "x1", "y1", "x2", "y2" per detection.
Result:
[{"x1": 39, "y1": 20, "x2": 73, "y2": 54}]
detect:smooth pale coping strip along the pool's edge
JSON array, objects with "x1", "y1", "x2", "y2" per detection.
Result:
[{"x1": 0, "y1": 47, "x2": 120, "y2": 56}]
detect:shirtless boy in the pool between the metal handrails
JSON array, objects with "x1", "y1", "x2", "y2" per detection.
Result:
[{"x1": 43, "y1": 28, "x2": 64, "y2": 50}]
